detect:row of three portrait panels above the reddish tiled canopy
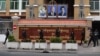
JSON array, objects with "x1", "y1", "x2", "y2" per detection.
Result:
[{"x1": 38, "y1": 5, "x2": 68, "y2": 18}]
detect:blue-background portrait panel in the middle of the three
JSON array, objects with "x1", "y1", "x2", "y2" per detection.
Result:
[{"x1": 47, "y1": 5, "x2": 57, "y2": 18}]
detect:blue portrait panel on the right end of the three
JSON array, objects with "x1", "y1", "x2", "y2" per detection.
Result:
[{"x1": 58, "y1": 5, "x2": 68, "y2": 18}]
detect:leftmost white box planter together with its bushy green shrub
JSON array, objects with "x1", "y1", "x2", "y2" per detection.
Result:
[{"x1": 6, "y1": 35, "x2": 19, "y2": 49}]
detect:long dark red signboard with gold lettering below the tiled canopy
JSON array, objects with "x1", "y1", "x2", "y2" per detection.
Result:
[{"x1": 19, "y1": 27, "x2": 82, "y2": 40}]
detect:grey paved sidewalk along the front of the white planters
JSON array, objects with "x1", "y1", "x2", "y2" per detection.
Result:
[{"x1": 0, "y1": 42, "x2": 100, "y2": 54}]
